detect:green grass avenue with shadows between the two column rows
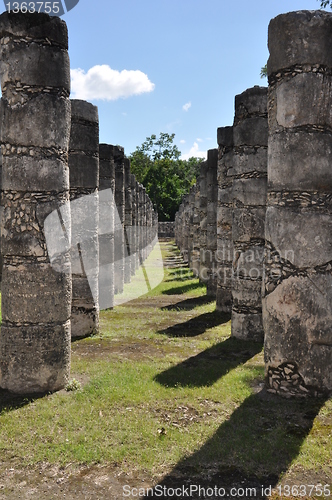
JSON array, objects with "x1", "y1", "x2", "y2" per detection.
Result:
[{"x1": 0, "y1": 244, "x2": 332, "y2": 496}]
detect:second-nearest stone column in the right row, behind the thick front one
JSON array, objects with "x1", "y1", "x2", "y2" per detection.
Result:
[{"x1": 232, "y1": 87, "x2": 268, "y2": 342}]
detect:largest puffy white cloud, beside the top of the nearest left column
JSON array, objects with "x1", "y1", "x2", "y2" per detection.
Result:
[{"x1": 70, "y1": 64, "x2": 155, "y2": 101}]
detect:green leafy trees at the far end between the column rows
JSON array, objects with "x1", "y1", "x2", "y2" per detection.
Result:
[{"x1": 129, "y1": 132, "x2": 201, "y2": 221}]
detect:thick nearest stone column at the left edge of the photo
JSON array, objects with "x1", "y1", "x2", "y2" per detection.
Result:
[{"x1": 0, "y1": 12, "x2": 72, "y2": 393}]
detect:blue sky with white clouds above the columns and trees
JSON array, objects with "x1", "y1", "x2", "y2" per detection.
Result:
[{"x1": 4, "y1": 0, "x2": 320, "y2": 158}]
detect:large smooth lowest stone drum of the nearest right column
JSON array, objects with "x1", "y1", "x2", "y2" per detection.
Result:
[{"x1": 263, "y1": 274, "x2": 332, "y2": 389}]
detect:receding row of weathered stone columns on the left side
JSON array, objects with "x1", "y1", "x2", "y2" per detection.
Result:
[{"x1": 0, "y1": 12, "x2": 158, "y2": 393}]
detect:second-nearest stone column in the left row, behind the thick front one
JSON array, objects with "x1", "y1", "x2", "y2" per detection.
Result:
[{"x1": 68, "y1": 100, "x2": 99, "y2": 338}]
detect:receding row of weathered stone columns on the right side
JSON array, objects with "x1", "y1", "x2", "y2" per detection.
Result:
[{"x1": 175, "y1": 11, "x2": 332, "y2": 397}]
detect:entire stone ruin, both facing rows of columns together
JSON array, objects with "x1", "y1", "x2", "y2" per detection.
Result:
[{"x1": 0, "y1": 11, "x2": 332, "y2": 397}]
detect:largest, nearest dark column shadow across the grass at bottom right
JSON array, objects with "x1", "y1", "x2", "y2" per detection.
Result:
[{"x1": 147, "y1": 390, "x2": 328, "y2": 499}]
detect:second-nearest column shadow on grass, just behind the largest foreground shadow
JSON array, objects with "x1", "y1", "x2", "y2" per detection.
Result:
[{"x1": 154, "y1": 338, "x2": 263, "y2": 387}]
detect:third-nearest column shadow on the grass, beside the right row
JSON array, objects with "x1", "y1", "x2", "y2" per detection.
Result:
[{"x1": 158, "y1": 310, "x2": 231, "y2": 337}]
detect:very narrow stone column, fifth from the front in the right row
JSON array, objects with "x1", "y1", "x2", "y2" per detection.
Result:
[{"x1": 199, "y1": 161, "x2": 209, "y2": 283}]
